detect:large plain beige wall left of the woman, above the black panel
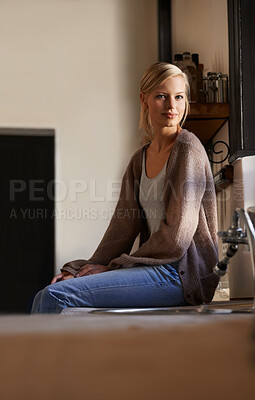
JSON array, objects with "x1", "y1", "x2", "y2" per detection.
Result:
[{"x1": 0, "y1": 0, "x2": 157, "y2": 270}]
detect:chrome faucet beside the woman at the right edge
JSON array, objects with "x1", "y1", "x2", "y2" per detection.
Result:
[{"x1": 213, "y1": 208, "x2": 255, "y2": 312}]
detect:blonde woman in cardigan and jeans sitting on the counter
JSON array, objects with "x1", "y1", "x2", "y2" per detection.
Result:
[{"x1": 32, "y1": 62, "x2": 218, "y2": 313}]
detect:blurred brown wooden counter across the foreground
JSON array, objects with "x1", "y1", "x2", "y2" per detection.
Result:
[{"x1": 0, "y1": 301, "x2": 255, "y2": 400}]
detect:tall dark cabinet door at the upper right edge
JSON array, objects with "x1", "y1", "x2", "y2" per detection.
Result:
[{"x1": 228, "y1": 0, "x2": 255, "y2": 161}]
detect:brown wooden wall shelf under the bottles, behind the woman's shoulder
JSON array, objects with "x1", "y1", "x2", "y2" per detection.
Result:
[{"x1": 184, "y1": 103, "x2": 229, "y2": 145}]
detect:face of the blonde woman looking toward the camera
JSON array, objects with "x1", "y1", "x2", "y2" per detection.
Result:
[{"x1": 142, "y1": 76, "x2": 186, "y2": 133}]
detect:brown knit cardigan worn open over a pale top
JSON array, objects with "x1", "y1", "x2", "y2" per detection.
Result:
[{"x1": 62, "y1": 129, "x2": 218, "y2": 305}]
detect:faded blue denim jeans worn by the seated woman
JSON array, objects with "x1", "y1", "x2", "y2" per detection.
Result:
[{"x1": 32, "y1": 264, "x2": 185, "y2": 313}]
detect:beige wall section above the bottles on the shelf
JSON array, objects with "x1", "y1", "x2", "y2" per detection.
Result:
[{"x1": 172, "y1": 0, "x2": 228, "y2": 73}]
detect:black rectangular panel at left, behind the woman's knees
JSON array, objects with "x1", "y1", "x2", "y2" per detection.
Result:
[{"x1": 0, "y1": 129, "x2": 54, "y2": 313}]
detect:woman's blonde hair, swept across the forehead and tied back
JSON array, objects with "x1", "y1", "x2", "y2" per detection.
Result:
[{"x1": 139, "y1": 62, "x2": 190, "y2": 140}]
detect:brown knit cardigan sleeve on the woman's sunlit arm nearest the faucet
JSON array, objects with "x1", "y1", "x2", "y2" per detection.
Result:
[{"x1": 106, "y1": 142, "x2": 214, "y2": 268}]
